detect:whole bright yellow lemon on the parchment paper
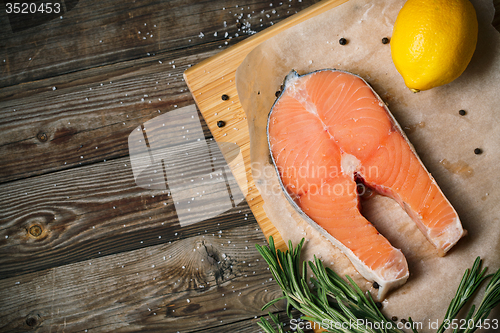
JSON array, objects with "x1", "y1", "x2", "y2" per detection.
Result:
[{"x1": 391, "y1": 0, "x2": 477, "y2": 92}]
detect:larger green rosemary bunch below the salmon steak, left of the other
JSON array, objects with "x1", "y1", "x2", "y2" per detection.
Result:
[{"x1": 256, "y1": 237, "x2": 403, "y2": 333}]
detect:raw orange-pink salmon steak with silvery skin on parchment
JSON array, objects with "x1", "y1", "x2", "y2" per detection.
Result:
[{"x1": 267, "y1": 69, "x2": 464, "y2": 299}]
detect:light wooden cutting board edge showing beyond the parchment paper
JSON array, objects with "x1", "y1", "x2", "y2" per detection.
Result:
[{"x1": 184, "y1": 0, "x2": 347, "y2": 249}]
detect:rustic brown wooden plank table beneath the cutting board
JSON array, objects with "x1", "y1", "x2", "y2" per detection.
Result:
[{"x1": 0, "y1": 0, "x2": 500, "y2": 332}]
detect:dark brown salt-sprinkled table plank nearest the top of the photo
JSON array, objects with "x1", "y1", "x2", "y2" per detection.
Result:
[{"x1": 0, "y1": 0, "x2": 315, "y2": 87}]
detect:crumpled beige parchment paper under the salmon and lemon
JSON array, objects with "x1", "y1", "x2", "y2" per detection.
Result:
[{"x1": 236, "y1": 0, "x2": 500, "y2": 326}]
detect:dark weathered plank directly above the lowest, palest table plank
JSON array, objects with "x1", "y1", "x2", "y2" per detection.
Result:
[{"x1": 0, "y1": 137, "x2": 254, "y2": 278}]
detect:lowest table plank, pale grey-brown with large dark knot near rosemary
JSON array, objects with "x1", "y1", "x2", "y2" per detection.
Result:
[{"x1": 0, "y1": 222, "x2": 290, "y2": 332}]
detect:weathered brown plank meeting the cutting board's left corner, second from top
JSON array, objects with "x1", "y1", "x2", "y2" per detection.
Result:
[{"x1": 0, "y1": 50, "x2": 213, "y2": 183}]
